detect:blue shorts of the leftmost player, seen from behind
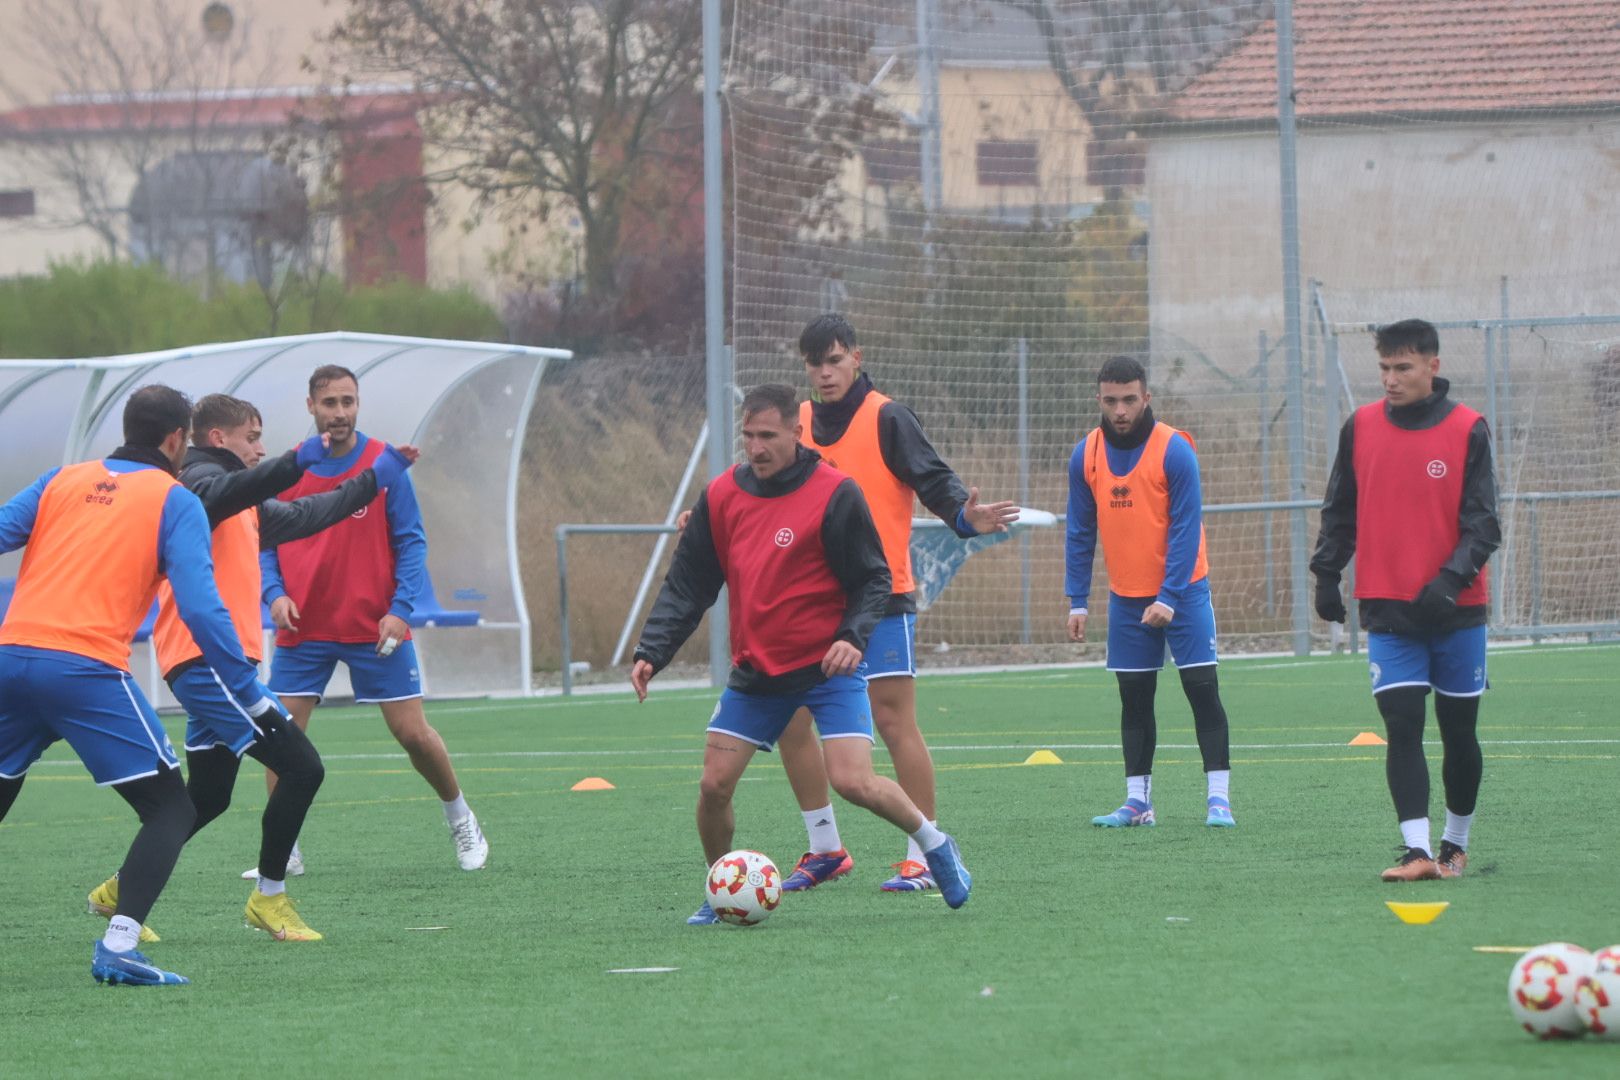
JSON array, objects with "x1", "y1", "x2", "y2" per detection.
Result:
[{"x1": 0, "y1": 644, "x2": 180, "y2": 787}]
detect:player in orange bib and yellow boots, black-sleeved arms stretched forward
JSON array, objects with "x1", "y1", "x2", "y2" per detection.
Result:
[{"x1": 89, "y1": 393, "x2": 416, "y2": 941}]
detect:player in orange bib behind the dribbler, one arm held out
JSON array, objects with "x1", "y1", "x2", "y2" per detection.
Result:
[{"x1": 779, "y1": 314, "x2": 1017, "y2": 892}]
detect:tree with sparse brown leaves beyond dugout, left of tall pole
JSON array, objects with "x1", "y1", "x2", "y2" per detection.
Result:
[{"x1": 329, "y1": 0, "x2": 701, "y2": 304}]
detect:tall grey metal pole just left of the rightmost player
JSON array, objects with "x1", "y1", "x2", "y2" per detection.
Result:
[{"x1": 1277, "y1": 0, "x2": 1311, "y2": 656}]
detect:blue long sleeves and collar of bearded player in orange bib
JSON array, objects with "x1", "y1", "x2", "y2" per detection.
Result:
[{"x1": 1064, "y1": 431, "x2": 1204, "y2": 610}]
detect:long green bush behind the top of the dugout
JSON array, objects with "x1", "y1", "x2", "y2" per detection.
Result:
[{"x1": 0, "y1": 261, "x2": 505, "y2": 359}]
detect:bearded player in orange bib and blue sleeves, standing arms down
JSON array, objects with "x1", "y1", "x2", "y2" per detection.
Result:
[{"x1": 1064, "y1": 356, "x2": 1236, "y2": 829}]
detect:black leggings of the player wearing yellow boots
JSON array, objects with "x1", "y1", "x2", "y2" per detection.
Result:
[{"x1": 186, "y1": 712, "x2": 326, "y2": 881}]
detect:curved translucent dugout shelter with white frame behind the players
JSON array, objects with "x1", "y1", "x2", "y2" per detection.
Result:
[{"x1": 0, "y1": 332, "x2": 572, "y2": 704}]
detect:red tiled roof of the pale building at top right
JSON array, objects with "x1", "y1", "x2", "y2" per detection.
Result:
[{"x1": 1170, "y1": 0, "x2": 1620, "y2": 121}]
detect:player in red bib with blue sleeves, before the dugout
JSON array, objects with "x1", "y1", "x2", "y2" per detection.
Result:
[{"x1": 255, "y1": 364, "x2": 489, "y2": 876}]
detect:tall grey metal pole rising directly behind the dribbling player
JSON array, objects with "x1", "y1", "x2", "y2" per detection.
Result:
[{"x1": 703, "y1": 0, "x2": 735, "y2": 687}]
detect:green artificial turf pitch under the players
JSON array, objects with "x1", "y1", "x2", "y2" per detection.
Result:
[{"x1": 0, "y1": 646, "x2": 1620, "y2": 1080}]
